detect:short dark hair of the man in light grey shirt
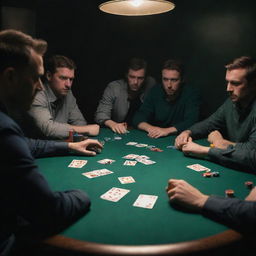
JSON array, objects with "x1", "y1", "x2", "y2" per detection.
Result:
[{"x1": 46, "y1": 55, "x2": 76, "y2": 74}]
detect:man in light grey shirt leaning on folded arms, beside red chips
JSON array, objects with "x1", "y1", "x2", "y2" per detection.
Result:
[{"x1": 28, "y1": 55, "x2": 99, "y2": 139}]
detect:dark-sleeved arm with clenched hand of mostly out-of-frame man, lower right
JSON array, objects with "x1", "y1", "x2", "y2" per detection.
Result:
[{"x1": 166, "y1": 179, "x2": 256, "y2": 235}]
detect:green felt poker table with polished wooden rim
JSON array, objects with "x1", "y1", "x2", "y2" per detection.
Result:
[{"x1": 36, "y1": 129, "x2": 256, "y2": 255}]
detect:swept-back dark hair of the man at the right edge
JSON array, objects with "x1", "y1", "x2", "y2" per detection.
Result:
[{"x1": 225, "y1": 56, "x2": 256, "y2": 84}]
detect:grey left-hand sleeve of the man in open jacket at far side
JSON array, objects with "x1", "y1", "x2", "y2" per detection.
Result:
[{"x1": 95, "y1": 83, "x2": 116, "y2": 125}]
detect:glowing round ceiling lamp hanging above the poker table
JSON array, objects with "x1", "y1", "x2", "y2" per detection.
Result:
[{"x1": 99, "y1": 0, "x2": 175, "y2": 16}]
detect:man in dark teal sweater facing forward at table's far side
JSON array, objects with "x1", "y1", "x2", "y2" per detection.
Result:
[{"x1": 133, "y1": 60, "x2": 200, "y2": 138}]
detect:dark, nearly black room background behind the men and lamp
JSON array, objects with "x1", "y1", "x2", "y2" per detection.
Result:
[{"x1": 0, "y1": 0, "x2": 256, "y2": 122}]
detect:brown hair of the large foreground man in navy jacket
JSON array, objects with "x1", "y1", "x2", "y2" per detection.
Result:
[{"x1": 0, "y1": 29, "x2": 47, "y2": 72}]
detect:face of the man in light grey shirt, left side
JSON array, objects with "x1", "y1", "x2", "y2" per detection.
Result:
[{"x1": 46, "y1": 67, "x2": 75, "y2": 98}]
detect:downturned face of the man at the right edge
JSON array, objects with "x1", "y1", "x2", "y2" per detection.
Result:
[{"x1": 226, "y1": 68, "x2": 252, "y2": 104}]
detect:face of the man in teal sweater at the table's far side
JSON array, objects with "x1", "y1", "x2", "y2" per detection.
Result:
[{"x1": 162, "y1": 69, "x2": 181, "y2": 98}]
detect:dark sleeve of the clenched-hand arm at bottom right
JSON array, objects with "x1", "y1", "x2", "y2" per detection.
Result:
[{"x1": 202, "y1": 196, "x2": 256, "y2": 234}]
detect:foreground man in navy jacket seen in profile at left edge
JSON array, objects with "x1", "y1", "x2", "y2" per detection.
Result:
[{"x1": 0, "y1": 30, "x2": 102, "y2": 256}]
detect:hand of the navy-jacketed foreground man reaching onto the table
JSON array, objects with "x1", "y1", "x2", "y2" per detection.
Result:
[{"x1": 68, "y1": 139, "x2": 103, "y2": 156}]
